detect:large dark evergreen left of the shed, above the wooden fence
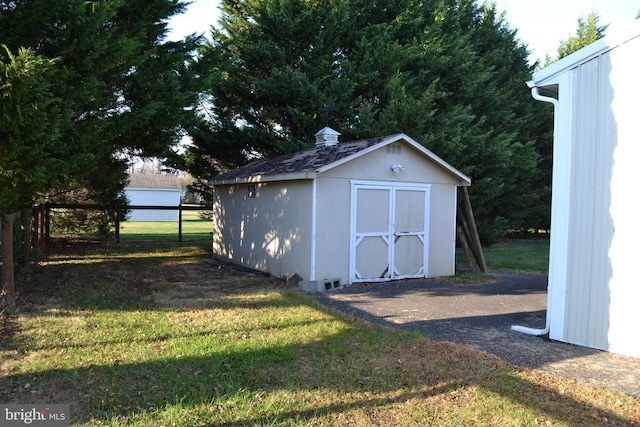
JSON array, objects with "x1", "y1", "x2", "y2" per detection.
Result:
[{"x1": 0, "y1": 0, "x2": 197, "y2": 212}]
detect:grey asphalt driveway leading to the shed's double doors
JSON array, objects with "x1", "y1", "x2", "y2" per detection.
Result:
[{"x1": 310, "y1": 272, "x2": 640, "y2": 396}]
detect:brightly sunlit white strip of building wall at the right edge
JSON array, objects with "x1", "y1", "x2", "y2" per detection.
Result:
[{"x1": 609, "y1": 32, "x2": 640, "y2": 357}]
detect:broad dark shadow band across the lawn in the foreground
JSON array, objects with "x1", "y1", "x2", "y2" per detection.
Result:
[{"x1": 0, "y1": 312, "x2": 626, "y2": 425}]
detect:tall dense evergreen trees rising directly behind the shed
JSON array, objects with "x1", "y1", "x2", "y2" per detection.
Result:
[{"x1": 183, "y1": 0, "x2": 551, "y2": 241}]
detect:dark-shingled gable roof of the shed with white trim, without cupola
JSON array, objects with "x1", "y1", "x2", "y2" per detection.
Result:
[{"x1": 211, "y1": 134, "x2": 471, "y2": 185}]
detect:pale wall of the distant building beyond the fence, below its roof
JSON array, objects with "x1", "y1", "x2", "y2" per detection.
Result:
[{"x1": 125, "y1": 188, "x2": 180, "y2": 221}]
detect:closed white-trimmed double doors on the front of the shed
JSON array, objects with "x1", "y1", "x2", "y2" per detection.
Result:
[{"x1": 350, "y1": 182, "x2": 430, "y2": 283}]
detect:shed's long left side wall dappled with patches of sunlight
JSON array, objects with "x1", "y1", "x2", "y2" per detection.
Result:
[{"x1": 213, "y1": 180, "x2": 312, "y2": 280}]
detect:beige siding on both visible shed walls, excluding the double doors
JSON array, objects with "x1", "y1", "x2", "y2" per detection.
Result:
[{"x1": 213, "y1": 142, "x2": 463, "y2": 284}]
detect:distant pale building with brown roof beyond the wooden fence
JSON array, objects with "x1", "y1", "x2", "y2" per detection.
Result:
[{"x1": 124, "y1": 173, "x2": 183, "y2": 221}]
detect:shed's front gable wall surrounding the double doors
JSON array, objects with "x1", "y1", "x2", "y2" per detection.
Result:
[{"x1": 315, "y1": 142, "x2": 460, "y2": 283}]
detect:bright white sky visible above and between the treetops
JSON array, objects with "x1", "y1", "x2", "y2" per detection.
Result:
[{"x1": 169, "y1": 0, "x2": 640, "y2": 63}]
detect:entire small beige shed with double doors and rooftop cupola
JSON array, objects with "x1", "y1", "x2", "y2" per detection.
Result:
[{"x1": 213, "y1": 127, "x2": 470, "y2": 290}]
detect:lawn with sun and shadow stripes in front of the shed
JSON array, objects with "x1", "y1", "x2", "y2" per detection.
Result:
[{"x1": 0, "y1": 242, "x2": 640, "y2": 427}]
